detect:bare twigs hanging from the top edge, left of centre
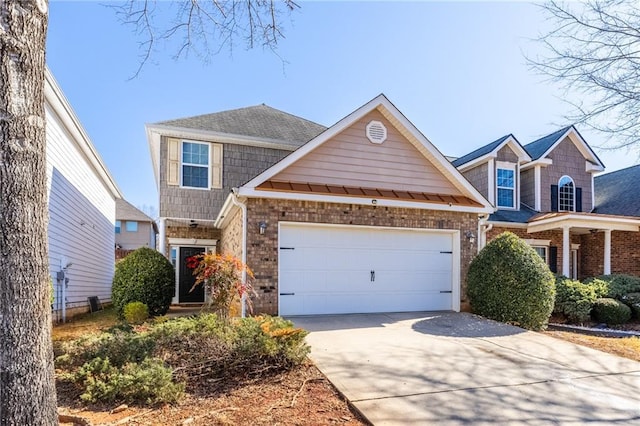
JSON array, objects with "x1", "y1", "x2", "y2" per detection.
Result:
[{"x1": 110, "y1": 0, "x2": 300, "y2": 78}]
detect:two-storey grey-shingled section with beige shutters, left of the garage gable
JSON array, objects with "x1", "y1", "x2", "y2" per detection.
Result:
[{"x1": 146, "y1": 104, "x2": 325, "y2": 303}]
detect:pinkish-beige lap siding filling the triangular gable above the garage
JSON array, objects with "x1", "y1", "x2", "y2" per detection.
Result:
[{"x1": 273, "y1": 111, "x2": 461, "y2": 195}]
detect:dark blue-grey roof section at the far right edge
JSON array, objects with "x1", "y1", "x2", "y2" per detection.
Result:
[{"x1": 594, "y1": 165, "x2": 640, "y2": 216}]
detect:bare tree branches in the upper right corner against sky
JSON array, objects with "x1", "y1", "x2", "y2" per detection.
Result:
[{"x1": 527, "y1": 0, "x2": 640, "y2": 152}]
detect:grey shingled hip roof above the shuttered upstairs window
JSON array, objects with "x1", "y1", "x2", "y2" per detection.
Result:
[{"x1": 155, "y1": 104, "x2": 326, "y2": 145}]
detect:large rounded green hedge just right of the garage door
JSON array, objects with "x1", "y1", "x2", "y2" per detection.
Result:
[{"x1": 467, "y1": 232, "x2": 555, "y2": 330}]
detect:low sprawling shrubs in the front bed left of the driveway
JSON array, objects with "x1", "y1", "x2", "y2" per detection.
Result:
[{"x1": 56, "y1": 313, "x2": 309, "y2": 404}]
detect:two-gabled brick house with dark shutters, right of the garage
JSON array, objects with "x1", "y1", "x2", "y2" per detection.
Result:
[{"x1": 453, "y1": 126, "x2": 640, "y2": 279}]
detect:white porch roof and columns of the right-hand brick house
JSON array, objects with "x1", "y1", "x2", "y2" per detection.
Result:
[{"x1": 527, "y1": 212, "x2": 640, "y2": 277}]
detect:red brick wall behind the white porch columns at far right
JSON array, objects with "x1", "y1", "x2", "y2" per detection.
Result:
[{"x1": 580, "y1": 231, "x2": 640, "y2": 278}]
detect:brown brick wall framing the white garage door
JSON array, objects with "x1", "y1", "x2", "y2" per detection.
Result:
[{"x1": 241, "y1": 199, "x2": 478, "y2": 314}]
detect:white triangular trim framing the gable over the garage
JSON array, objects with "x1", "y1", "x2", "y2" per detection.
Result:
[{"x1": 228, "y1": 94, "x2": 494, "y2": 216}]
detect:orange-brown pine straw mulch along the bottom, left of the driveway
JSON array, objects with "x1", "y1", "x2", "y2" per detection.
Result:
[{"x1": 58, "y1": 362, "x2": 369, "y2": 426}]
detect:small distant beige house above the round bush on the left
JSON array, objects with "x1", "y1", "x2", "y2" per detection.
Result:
[{"x1": 115, "y1": 199, "x2": 158, "y2": 251}]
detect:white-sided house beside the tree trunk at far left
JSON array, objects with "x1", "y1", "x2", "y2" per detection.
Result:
[{"x1": 45, "y1": 69, "x2": 122, "y2": 319}]
